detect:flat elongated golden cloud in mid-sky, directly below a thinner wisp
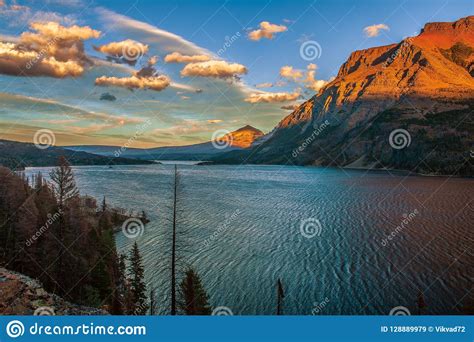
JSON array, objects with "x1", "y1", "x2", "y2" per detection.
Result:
[{"x1": 181, "y1": 61, "x2": 247, "y2": 78}]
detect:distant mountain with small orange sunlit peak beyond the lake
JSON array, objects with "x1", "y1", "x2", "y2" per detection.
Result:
[{"x1": 68, "y1": 125, "x2": 264, "y2": 161}]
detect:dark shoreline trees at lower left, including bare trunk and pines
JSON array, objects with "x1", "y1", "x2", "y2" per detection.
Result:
[{"x1": 0, "y1": 157, "x2": 211, "y2": 315}]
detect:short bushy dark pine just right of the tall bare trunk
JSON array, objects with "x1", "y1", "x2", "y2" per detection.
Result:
[{"x1": 180, "y1": 268, "x2": 212, "y2": 315}]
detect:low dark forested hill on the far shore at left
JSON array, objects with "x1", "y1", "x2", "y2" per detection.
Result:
[{"x1": 0, "y1": 140, "x2": 153, "y2": 169}]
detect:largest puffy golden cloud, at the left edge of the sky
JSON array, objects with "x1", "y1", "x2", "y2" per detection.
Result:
[{"x1": 0, "y1": 22, "x2": 100, "y2": 78}]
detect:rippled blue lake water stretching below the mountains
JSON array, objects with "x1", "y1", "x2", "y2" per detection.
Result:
[{"x1": 26, "y1": 164, "x2": 474, "y2": 315}]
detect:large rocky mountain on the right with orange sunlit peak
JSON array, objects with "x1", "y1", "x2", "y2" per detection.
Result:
[{"x1": 213, "y1": 16, "x2": 474, "y2": 175}]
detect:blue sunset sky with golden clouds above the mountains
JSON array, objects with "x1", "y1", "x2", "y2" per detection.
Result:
[{"x1": 0, "y1": 0, "x2": 474, "y2": 148}]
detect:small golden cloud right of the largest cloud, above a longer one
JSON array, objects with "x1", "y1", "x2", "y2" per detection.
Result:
[{"x1": 94, "y1": 39, "x2": 148, "y2": 65}]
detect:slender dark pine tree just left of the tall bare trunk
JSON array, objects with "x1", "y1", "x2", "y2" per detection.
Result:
[{"x1": 129, "y1": 242, "x2": 148, "y2": 315}]
